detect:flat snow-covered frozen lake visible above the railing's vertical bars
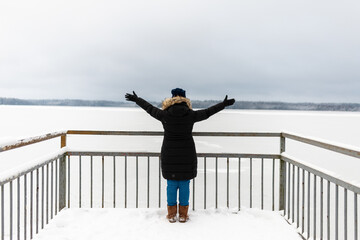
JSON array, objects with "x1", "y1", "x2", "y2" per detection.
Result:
[{"x1": 0, "y1": 106, "x2": 360, "y2": 183}]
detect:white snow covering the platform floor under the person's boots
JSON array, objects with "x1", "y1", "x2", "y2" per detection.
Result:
[{"x1": 34, "y1": 209, "x2": 301, "y2": 240}]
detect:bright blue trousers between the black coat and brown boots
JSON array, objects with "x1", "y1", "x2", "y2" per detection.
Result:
[{"x1": 166, "y1": 180, "x2": 190, "y2": 206}]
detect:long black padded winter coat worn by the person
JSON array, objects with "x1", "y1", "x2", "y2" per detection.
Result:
[{"x1": 136, "y1": 98, "x2": 225, "y2": 180}]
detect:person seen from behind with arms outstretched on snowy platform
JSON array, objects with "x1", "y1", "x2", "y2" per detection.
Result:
[{"x1": 125, "y1": 88, "x2": 235, "y2": 223}]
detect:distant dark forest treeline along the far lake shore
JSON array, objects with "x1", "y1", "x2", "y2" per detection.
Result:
[{"x1": 0, "y1": 98, "x2": 360, "y2": 112}]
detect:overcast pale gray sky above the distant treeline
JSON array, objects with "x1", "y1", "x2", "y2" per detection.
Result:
[{"x1": 0, "y1": 0, "x2": 360, "y2": 102}]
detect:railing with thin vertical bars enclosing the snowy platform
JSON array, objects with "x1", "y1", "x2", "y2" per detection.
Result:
[{"x1": 0, "y1": 130, "x2": 360, "y2": 240}]
